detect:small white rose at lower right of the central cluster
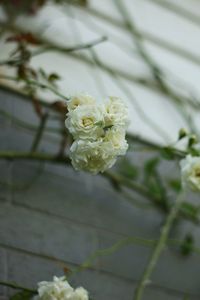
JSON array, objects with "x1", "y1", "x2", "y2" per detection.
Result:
[{"x1": 104, "y1": 126, "x2": 128, "y2": 155}]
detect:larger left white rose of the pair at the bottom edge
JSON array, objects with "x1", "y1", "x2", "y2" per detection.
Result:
[{"x1": 38, "y1": 276, "x2": 74, "y2": 300}]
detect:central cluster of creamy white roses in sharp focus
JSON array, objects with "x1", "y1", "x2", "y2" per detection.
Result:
[{"x1": 65, "y1": 94, "x2": 129, "y2": 174}]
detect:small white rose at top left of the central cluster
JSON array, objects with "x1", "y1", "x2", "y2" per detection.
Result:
[{"x1": 67, "y1": 94, "x2": 96, "y2": 111}]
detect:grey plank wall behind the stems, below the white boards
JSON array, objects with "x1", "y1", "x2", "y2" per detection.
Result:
[{"x1": 0, "y1": 89, "x2": 200, "y2": 300}]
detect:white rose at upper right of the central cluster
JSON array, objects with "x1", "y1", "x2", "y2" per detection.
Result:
[{"x1": 104, "y1": 97, "x2": 129, "y2": 128}]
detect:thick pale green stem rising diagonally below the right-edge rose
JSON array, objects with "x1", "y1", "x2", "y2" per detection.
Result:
[{"x1": 133, "y1": 193, "x2": 183, "y2": 300}]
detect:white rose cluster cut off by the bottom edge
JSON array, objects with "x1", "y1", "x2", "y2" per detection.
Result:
[{"x1": 34, "y1": 276, "x2": 89, "y2": 300}]
